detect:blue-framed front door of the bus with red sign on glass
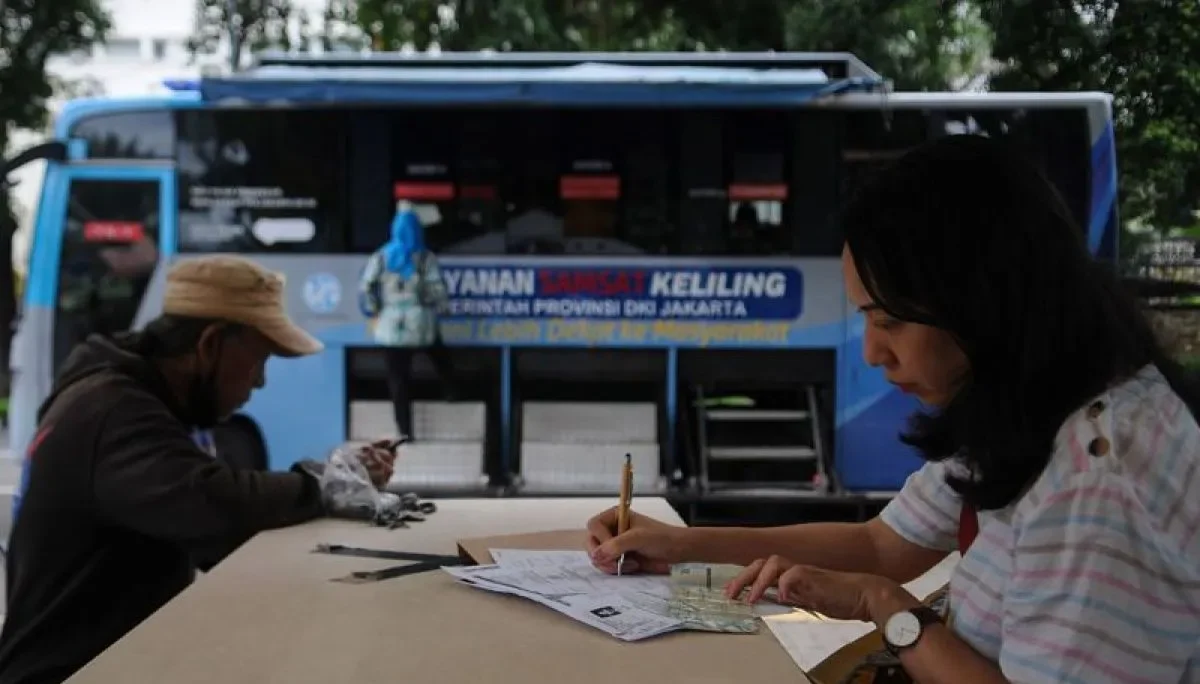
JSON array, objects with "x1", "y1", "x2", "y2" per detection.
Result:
[{"x1": 11, "y1": 163, "x2": 175, "y2": 470}]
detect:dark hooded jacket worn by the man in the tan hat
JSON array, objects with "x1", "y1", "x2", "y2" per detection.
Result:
[{"x1": 0, "y1": 336, "x2": 322, "y2": 684}]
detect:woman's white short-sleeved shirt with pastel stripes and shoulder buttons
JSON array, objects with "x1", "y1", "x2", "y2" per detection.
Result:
[{"x1": 881, "y1": 366, "x2": 1200, "y2": 684}]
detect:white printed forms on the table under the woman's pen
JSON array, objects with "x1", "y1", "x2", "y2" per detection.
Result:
[{"x1": 443, "y1": 548, "x2": 791, "y2": 641}]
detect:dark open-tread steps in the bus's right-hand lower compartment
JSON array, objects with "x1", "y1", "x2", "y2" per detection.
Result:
[{"x1": 695, "y1": 385, "x2": 832, "y2": 492}]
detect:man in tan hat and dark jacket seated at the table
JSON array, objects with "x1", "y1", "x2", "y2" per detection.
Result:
[{"x1": 0, "y1": 256, "x2": 391, "y2": 684}]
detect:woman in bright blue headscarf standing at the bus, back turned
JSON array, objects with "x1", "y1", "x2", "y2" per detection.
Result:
[{"x1": 359, "y1": 202, "x2": 457, "y2": 440}]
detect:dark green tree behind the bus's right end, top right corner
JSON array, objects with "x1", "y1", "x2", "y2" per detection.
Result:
[{"x1": 982, "y1": 0, "x2": 1200, "y2": 234}]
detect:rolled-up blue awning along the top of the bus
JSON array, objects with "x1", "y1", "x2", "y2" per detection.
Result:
[{"x1": 200, "y1": 62, "x2": 883, "y2": 107}]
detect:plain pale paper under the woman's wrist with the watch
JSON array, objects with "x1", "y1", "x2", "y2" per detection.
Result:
[{"x1": 763, "y1": 553, "x2": 959, "y2": 672}]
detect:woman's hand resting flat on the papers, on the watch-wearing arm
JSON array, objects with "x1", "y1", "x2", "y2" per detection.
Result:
[{"x1": 758, "y1": 565, "x2": 904, "y2": 622}]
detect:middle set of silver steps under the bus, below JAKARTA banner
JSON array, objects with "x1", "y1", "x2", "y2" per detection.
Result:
[{"x1": 512, "y1": 402, "x2": 665, "y2": 496}]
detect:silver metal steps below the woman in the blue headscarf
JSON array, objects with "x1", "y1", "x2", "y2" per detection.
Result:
[{"x1": 349, "y1": 401, "x2": 488, "y2": 493}]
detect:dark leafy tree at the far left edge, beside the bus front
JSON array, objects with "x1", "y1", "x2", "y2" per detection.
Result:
[{"x1": 0, "y1": 0, "x2": 109, "y2": 394}]
